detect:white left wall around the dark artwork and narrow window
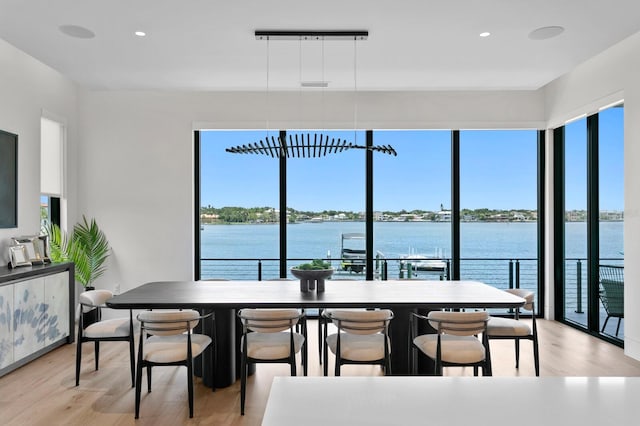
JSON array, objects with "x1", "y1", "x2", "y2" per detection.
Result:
[{"x1": 0, "y1": 40, "x2": 77, "y2": 267}]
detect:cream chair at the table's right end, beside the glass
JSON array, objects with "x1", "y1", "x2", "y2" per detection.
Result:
[{"x1": 487, "y1": 288, "x2": 540, "y2": 376}]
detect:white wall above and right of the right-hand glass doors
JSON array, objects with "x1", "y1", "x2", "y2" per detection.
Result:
[{"x1": 544, "y1": 34, "x2": 640, "y2": 359}]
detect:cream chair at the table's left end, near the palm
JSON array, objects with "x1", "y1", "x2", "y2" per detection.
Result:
[{"x1": 76, "y1": 290, "x2": 135, "y2": 387}]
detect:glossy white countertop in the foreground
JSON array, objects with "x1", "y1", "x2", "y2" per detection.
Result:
[{"x1": 262, "y1": 376, "x2": 640, "y2": 426}]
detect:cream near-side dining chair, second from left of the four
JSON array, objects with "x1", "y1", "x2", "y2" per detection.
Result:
[{"x1": 238, "y1": 309, "x2": 307, "y2": 415}]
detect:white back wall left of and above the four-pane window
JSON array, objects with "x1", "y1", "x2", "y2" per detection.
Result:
[{"x1": 77, "y1": 91, "x2": 544, "y2": 291}]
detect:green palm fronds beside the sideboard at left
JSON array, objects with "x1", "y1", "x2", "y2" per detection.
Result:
[{"x1": 47, "y1": 216, "x2": 111, "y2": 290}]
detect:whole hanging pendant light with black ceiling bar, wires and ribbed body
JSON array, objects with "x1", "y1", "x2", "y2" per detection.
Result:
[{"x1": 226, "y1": 30, "x2": 397, "y2": 158}]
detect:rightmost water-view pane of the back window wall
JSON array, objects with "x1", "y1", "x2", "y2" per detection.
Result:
[{"x1": 460, "y1": 130, "x2": 538, "y2": 312}]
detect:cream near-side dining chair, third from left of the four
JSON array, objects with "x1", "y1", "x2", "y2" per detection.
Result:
[{"x1": 323, "y1": 309, "x2": 393, "y2": 376}]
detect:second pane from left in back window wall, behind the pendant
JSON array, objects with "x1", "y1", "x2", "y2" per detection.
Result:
[{"x1": 286, "y1": 130, "x2": 366, "y2": 279}]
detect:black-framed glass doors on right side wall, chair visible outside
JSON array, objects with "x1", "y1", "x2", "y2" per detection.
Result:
[{"x1": 554, "y1": 103, "x2": 624, "y2": 344}]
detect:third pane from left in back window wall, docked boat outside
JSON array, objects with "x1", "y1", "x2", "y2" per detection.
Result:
[{"x1": 373, "y1": 130, "x2": 451, "y2": 279}]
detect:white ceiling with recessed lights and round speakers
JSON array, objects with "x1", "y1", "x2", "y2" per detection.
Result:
[{"x1": 0, "y1": 0, "x2": 640, "y2": 90}]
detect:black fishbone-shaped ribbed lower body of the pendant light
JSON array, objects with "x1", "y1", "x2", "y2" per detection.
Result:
[{"x1": 226, "y1": 133, "x2": 398, "y2": 158}]
